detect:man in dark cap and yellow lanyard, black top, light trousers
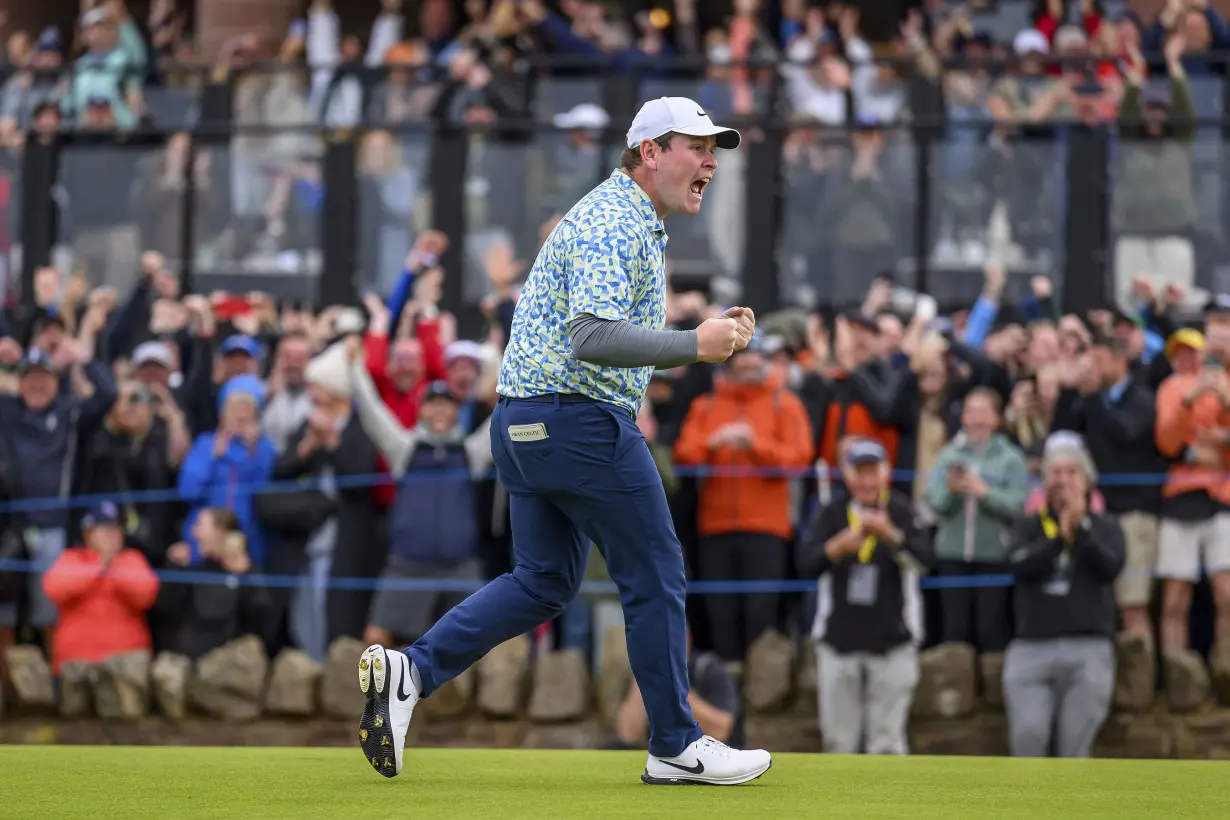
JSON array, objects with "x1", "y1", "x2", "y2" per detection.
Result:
[{"x1": 798, "y1": 438, "x2": 935, "y2": 755}]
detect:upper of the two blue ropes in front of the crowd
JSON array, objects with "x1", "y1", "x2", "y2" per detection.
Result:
[{"x1": 0, "y1": 467, "x2": 1180, "y2": 515}]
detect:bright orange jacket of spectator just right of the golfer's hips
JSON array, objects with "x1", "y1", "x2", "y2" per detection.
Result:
[{"x1": 675, "y1": 380, "x2": 812, "y2": 538}]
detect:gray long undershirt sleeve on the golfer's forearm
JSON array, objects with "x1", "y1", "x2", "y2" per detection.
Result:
[{"x1": 568, "y1": 313, "x2": 696, "y2": 368}]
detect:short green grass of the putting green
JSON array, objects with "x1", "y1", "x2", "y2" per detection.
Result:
[{"x1": 0, "y1": 746, "x2": 1230, "y2": 820}]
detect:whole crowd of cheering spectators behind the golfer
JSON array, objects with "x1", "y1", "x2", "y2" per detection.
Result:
[{"x1": 0, "y1": 0, "x2": 1230, "y2": 754}]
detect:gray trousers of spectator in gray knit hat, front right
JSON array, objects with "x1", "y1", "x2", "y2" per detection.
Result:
[{"x1": 1004, "y1": 638, "x2": 1114, "y2": 757}]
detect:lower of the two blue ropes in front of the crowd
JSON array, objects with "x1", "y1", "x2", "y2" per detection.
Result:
[{"x1": 0, "y1": 558, "x2": 1014, "y2": 596}]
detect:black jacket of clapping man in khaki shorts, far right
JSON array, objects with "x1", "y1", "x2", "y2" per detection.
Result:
[{"x1": 1054, "y1": 379, "x2": 1167, "y2": 515}]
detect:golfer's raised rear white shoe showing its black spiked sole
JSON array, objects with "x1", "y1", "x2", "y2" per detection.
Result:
[{"x1": 359, "y1": 643, "x2": 418, "y2": 777}]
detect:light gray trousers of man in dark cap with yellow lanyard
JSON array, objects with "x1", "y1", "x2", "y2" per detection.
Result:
[{"x1": 815, "y1": 643, "x2": 919, "y2": 755}]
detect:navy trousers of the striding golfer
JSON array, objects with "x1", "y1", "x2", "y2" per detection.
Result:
[{"x1": 406, "y1": 396, "x2": 701, "y2": 757}]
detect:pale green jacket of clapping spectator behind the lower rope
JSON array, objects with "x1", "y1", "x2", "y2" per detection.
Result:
[{"x1": 926, "y1": 433, "x2": 1030, "y2": 563}]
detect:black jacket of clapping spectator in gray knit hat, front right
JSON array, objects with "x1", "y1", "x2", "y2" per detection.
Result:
[{"x1": 1007, "y1": 515, "x2": 1125, "y2": 641}]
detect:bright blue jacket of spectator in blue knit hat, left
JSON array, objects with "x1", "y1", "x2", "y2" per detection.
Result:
[{"x1": 180, "y1": 433, "x2": 278, "y2": 568}]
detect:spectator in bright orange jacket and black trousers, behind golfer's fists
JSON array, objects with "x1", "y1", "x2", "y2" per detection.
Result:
[{"x1": 675, "y1": 337, "x2": 813, "y2": 661}]
